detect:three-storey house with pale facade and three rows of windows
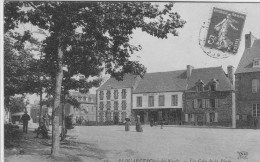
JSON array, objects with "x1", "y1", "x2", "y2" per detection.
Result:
[{"x1": 97, "y1": 74, "x2": 140, "y2": 124}]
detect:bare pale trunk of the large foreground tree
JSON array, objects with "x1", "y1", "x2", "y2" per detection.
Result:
[{"x1": 51, "y1": 46, "x2": 63, "y2": 156}]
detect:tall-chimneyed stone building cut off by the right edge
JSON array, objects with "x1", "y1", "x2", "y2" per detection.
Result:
[{"x1": 235, "y1": 33, "x2": 260, "y2": 128}]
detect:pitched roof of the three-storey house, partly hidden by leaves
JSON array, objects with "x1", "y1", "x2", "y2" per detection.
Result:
[{"x1": 97, "y1": 74, "x2": 140, "y2": 90}]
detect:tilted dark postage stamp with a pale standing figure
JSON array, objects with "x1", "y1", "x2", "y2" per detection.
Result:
[{"x1": 205, "y1": 7, "x2": 246, "y2": 54}]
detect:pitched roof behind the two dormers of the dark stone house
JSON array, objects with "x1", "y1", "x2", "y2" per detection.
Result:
[{"x1": 187, "y1": 66, "x2": 233, "y2": 91}]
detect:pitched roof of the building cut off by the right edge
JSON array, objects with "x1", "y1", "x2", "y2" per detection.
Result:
[{"x1": 235, "y1": 39, "x2": 260, "y2": 74}]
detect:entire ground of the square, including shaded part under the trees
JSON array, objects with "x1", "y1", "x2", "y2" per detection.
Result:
[{"x1": 5, "y1": 125, "x2": 260, "y2": 162}]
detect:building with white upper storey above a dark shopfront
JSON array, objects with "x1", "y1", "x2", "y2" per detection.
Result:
[{"x1": 132, "y1": 70, "x2": 187, "y2": 124}]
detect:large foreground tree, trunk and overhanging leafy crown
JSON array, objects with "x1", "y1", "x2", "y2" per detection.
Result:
[{"x1": 4, "y1": 2, "x2": 185, "y2": 156}]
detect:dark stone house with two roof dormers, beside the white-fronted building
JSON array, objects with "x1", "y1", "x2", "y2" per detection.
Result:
[{"x1": 184, "y1": 65, "x2": 235, "y2": 127}]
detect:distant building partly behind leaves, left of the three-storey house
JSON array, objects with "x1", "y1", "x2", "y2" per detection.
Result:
[{"x1": 65, "y1": 91, "x2": 96, "y2": 124}]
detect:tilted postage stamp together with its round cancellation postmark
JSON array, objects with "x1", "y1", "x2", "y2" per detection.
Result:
[{"x1": 200, "y1": 7, "x2": 246, "y2": 58}]
